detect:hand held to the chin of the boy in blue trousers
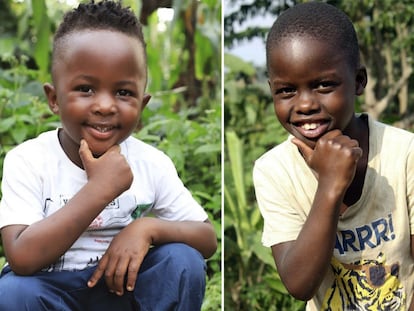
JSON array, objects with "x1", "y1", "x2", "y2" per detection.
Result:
[{"x1": 79, "y1": 140, "x2": 133, "y2": 201}]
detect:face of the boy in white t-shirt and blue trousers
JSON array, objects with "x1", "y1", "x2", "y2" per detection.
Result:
[{"x1": 45, "y1": 30, "x2": 148, "y2": 163}]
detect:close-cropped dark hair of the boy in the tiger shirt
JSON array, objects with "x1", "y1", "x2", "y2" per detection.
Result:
[{"x1": 266, "y1": 2, "x2": 360, "y2": 68}]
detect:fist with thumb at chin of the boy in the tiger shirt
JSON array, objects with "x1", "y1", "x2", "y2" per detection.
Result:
[{"x1": 292, "y1": 130, "x2": 362, "y2": 191}]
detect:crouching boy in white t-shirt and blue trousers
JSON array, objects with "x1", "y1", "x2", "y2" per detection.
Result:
[{"x1": 0, "y1": 1, "x2": 216, "y2": 311}]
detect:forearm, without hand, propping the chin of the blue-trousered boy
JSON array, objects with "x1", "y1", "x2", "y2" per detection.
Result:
[{"x1": 2, "y1": 184, "x2": 113, "y2": 274}]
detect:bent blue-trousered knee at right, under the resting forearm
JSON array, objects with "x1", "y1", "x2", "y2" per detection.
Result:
[{"x1": 134, "y1": 243, "x2": 206, "y2": 311}]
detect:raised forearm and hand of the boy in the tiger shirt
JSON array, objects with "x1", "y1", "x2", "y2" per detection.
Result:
[{"x1": 278, "y1": 129, "x2": 366, "y2": 300}]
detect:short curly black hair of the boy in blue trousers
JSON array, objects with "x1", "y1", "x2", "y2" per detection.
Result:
[{"x1": 52, "y1": 0, "x2": 146, "y2": 70}]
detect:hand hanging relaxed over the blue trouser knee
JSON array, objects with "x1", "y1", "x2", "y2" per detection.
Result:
[{"x1": 88, "y1": 221, "x2": 151, "y2": 296}]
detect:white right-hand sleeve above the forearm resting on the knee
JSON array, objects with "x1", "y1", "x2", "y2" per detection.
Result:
[{"x1": 153, "y1": 156, "x2": 208, "y2": 221}]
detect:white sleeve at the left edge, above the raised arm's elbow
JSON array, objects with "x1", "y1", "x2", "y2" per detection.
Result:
[{"x1": 0, "y1": 150, "x2": 44, "y2": 228}]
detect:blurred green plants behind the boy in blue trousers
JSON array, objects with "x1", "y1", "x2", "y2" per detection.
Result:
[{"x1": 0, "y1": 0, "x2": 222, "y2": 310}]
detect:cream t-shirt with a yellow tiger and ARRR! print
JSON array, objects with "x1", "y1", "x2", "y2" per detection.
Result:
[{"x1": 253, "y1": 118, "x2": 414, "y2": 311}]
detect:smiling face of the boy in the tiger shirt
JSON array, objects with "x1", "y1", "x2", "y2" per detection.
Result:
[{"x1": 268, "y1": 36, "x2": 366, "y2": 148}]
